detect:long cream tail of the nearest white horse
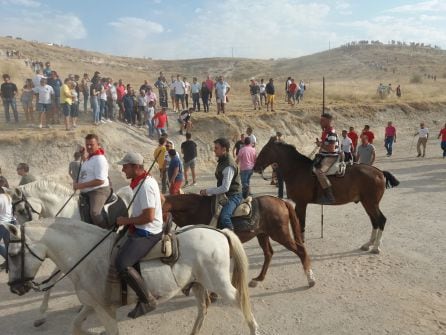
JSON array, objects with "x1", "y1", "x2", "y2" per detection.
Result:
[{"x1": 223, "y1": 229, "x2": 254, "y2": 323}]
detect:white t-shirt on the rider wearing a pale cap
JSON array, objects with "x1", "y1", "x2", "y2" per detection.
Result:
[{"x1": 131, "y1": 176, "x2": 163, "y2": 234}]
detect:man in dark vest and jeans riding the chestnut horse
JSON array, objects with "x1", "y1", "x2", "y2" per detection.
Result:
[{"x1": 200, "y1": 138, "x2": 243, "y2": 230}]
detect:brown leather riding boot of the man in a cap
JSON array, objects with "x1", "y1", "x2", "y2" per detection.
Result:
[{"x1": 120, "y1": 266, "x2": 156, "y2": 319}]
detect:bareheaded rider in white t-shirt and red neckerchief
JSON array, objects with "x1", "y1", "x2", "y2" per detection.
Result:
[{"x1": 73, "y1": 134, "x2": 110, "y2": 228}]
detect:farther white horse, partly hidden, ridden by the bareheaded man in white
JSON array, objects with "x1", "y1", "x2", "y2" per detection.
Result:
[{"x1": 8, "y1": 180, "x2": 133, "y2": 327}]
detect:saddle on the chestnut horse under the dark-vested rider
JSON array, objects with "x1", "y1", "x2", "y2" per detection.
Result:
[{"x1": 209, "y1": 194, "x2": 258, "y2": 231}]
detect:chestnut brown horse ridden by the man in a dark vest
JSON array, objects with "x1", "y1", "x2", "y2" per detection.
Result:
[{"x1": 163, "y1": 194, "x2": 316, "y2": 287}]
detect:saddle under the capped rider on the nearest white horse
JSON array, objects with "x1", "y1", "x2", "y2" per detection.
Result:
[{"x1": 106, "y1": 215, "x2": 180, "y2": 306}]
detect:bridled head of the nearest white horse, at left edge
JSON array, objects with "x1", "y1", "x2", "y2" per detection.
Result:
[{"x1": 0, "y1": 224, "x2": 46, "y2": 295}]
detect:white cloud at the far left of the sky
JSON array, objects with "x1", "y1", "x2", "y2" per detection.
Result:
[{"x1": 0, "y1": 10, "x2": 87, "y2": 44}]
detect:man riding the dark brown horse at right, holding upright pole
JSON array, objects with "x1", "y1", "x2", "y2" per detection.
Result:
[{"x1": 313, "y1": 112, "x2": 339, "y2": 205}]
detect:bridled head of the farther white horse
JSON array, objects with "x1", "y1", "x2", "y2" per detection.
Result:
[{"x1": 8, "y1": 187, "x2": 42, "y2": 223}]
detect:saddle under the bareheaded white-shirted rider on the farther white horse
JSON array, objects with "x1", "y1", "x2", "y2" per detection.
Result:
[{"x1": 79, "y1": 189, "x2": 128, "y2": 229}]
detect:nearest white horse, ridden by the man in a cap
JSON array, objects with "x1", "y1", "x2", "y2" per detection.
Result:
[{"x1": 5, "y1": 218, "x2": 259, "y2": 335}]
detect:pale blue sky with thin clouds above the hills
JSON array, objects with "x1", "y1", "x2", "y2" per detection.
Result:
[{"x1": 0, "y1": 0, "x2": 446, "y2": 59}]
